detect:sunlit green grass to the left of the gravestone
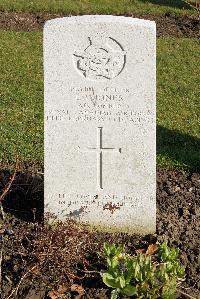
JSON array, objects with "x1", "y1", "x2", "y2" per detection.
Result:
[{"x1": 0, "y1": 32, "x2": 43, "y2": 165}]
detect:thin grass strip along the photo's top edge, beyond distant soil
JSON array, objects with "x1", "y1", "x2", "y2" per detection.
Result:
[{"x1": 0, "y1": 0, "x2": 194, "y2": 15}]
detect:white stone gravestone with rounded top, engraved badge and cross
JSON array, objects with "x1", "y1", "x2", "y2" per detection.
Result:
[{"x1": 44, "y1": 16, "x2": 156, "y2": 234}]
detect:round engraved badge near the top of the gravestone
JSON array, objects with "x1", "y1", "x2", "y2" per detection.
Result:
[{"x1": 73, "y1": 34, "x2": 126, "y2": 81}]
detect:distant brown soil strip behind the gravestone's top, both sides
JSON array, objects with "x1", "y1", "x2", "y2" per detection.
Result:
[{"x1": 0, "y1": 12, "x2": 200, "y2": 37}]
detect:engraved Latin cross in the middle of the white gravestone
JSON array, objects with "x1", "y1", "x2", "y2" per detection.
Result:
[{"x1": 84, "y1": 127, "x2": 121, "y2": 189}]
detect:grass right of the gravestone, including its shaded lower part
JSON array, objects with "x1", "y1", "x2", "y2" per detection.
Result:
[{"x1": 157, "y1": 38, "x2": 200, "y2": 170}]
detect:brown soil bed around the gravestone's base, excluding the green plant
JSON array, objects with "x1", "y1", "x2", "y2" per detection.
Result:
[{"x1": 0, "y1": 169, "x2": 200, "y2": 299}]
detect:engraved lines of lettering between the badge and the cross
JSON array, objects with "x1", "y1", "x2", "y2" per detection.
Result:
[{"x1": 46, "y1": 86, "x2": 155, "y2": 126}]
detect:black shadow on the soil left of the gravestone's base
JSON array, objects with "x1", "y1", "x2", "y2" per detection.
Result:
[{"x1": 0, "y1": 170, "x2": 44, "y2": 222}]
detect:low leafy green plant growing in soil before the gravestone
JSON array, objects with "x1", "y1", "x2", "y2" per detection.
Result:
[{"x1": 101, "y1": 243, "x2": 184, "y2": 299}]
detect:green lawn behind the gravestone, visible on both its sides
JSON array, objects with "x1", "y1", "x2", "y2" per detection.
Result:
[{"x1": 0, "y1": 32, "x2": 200, "y2": 169}]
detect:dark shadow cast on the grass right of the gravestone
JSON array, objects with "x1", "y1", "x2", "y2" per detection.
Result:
[{"x1": 157, "y1": 126, "x2": 200, "y2": 171}]
